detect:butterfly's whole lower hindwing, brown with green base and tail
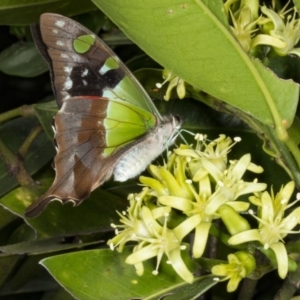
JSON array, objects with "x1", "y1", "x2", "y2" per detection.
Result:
[{"x1": 26, "y1": 97, "x2": 155, "y2": 217}]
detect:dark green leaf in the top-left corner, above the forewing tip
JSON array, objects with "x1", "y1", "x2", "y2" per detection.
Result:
[{"x1": 0, "y1": 0, "x2": 96, "y2": 25}]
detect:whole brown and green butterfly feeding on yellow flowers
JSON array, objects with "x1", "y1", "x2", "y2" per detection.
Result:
[{"x1": 25, "y1": 13, "x2": 181, "y2": 217}]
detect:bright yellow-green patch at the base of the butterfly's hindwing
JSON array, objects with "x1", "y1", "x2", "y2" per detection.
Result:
[{"x1": 103, "y1": 101, "x2": 156, "y2": 156}]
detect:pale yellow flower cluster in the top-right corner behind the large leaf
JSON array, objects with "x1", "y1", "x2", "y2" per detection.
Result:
[{"x1": 224, "y1": 0, "x2": 300, "y2": 56}]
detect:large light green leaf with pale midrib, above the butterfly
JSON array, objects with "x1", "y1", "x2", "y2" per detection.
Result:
[{"x1": 93, "y1": 0, "x2": 299, "y2": 126}]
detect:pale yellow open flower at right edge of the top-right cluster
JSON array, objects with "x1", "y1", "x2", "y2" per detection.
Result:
[{"x1": 251, "y1": 6, "x2": 300, "y2": 56}]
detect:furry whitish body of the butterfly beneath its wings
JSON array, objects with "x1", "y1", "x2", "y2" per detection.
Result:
[{"x1": 113, "y1": 116, "x2": 179, "y2": 181}]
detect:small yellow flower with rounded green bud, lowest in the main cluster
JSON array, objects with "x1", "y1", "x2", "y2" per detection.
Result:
[{"x1": 211, "y1": 251, "x2": 256, "y2": 293}]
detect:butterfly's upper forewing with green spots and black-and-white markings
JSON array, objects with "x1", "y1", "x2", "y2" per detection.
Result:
[{"x1": 33, "y1": 14, "x2": 160, "y2": 118}]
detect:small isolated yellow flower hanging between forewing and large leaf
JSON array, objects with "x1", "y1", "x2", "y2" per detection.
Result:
[{"x1": 156, "y1": 69, "x2": 186, "y2": 101}]
